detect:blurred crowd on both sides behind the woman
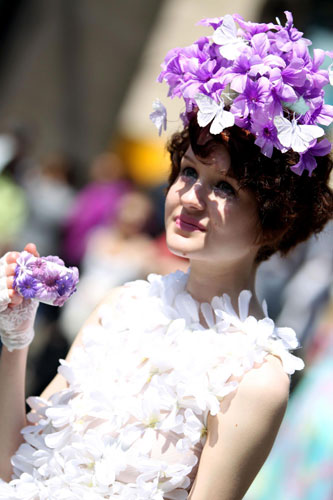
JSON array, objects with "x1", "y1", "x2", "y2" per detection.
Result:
[{"x1": 0, "y1": 127, "x2": 333, "y2": 500}]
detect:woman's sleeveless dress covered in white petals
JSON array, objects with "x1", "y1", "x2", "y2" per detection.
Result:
[{"x1": 0, "y1": 271, "x2": 303, "y2": 500}]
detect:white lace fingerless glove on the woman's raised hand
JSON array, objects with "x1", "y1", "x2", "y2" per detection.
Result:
[{"x1": 0, "y1": 250, "x2": 39, "y2": 352}]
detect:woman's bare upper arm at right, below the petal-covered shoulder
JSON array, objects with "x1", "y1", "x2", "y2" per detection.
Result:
[{"x1": 189, "y1": 356, "x2": 289, "y2": 500}]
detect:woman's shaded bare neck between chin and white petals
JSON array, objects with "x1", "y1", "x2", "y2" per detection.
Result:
[{"x1": 186, "y1": 261, "x2": 263, "y2": 317}]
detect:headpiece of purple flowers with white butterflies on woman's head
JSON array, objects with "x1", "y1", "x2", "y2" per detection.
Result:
[{"x1": 150, "y1": 11, "x2": 333, "y2": 175}]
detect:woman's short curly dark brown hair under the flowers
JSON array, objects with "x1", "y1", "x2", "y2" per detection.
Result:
[{"x1": 167, "y1": 117, "x2": 333, "y2": 262}]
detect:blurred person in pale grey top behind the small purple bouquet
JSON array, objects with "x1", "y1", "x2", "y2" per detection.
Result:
[{"x1": 16, "y1": 153, "x2": 75, "y2": 394}]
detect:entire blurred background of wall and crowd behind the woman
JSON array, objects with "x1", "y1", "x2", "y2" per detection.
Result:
[{"x1": 0, "y1": 0, "x2": 333, "y2": 500}]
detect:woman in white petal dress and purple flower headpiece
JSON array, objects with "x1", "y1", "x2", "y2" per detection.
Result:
[{"x1": 0, "y1": 13, "x2": 333, "y2": 500}]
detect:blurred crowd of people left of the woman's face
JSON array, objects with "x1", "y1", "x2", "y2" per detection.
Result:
[{"x1": 0, "y1": 131, "x2": 187, "y2": 395}]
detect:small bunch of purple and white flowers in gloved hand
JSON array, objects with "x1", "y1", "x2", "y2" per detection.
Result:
[{"x1": 13, "y1": 251, "x2": 79, "y2": 306}]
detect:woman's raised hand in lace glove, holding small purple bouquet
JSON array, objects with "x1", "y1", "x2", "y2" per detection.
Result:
[{"x1": 0, "y1": 243, "x2": 39, "y2": 351}]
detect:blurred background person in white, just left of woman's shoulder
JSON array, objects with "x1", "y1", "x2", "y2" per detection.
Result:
[{"x1": 61, "y1": 189, "x2": 158, "y2": 342}]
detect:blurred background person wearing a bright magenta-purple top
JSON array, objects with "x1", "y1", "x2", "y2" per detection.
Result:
[{"x1": 61, "y1": 152, "x2": 132, "y2": 266}]
